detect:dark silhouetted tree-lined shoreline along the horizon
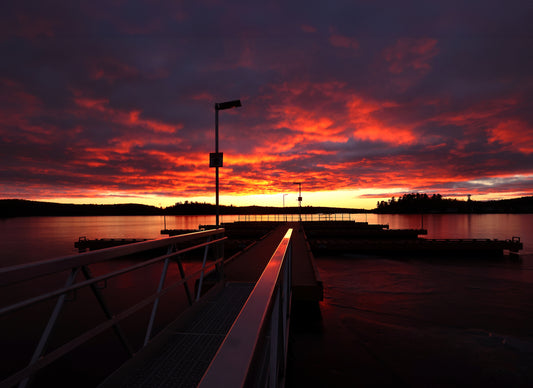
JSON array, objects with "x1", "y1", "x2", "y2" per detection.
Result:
[{"x1": 0, "y1": 197, "x2": 533, "y2": 218}]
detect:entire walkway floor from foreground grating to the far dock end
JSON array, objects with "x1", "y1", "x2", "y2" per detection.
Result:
[{"x1": 100, "y1": 223, "x2": 322, "y2": 387}]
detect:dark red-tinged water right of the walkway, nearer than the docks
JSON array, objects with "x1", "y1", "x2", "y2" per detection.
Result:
[{"x1": 288, "y1": 250, "x2": 533, "y2": 387}]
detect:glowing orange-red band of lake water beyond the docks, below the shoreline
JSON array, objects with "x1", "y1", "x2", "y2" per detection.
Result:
[{"x1": 0, "y1": 214, "x2": 533, "y2": 266}]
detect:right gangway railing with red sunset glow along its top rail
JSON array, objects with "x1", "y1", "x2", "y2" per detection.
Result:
[{"x1": 198, "y1": 229, "x2": 292, "y2": 388}]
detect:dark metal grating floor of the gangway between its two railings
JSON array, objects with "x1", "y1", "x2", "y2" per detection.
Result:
[{"x1": 100, "y1": 283, "x2": 254, "y2": 388}]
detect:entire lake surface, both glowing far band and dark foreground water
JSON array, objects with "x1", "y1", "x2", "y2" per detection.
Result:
[{"x1": 0, "y1": 214, "x2": 533, "y2": 387}]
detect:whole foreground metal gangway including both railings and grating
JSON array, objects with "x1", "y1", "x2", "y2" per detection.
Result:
[{"x1": 0, "y1": 228, "x2": 292, "y2": 388}]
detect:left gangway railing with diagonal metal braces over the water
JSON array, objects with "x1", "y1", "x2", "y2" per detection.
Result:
[{"x1": 0, "y1": 228, "x2": 226, "y2": 387}]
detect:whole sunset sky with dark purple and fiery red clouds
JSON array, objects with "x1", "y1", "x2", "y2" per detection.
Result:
[{"x1": 0, "y1": 0, "x2": 533, "y2": 208}]
